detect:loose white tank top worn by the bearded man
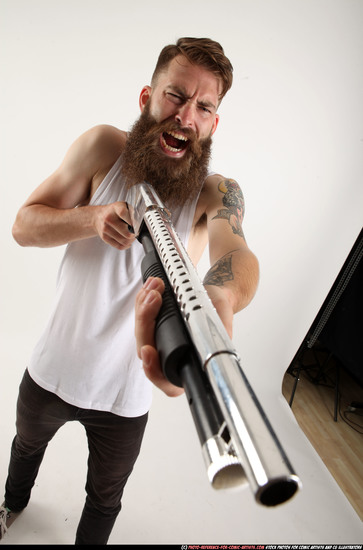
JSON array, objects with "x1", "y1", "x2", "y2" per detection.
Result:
[{"x1": 29, "y1": 157, "x2": 197, "y2": 417}]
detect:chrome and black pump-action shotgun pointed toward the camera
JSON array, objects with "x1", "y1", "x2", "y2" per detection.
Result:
[{"x1": 126, "y1": 183, "x2": 301, "y2": 506}]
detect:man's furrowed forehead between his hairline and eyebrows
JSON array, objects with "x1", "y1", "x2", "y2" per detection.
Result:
[{"x1": 156, "y1": 55, "x2": 222, "y2": 105}]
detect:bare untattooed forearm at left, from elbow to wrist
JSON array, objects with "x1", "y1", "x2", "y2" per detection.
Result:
[{"x1": 13, "y1": 204, "x2": 100, "y2": 247}]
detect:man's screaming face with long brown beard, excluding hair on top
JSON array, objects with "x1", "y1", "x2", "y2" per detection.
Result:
[{"x1": 123, "y1": 56, "x2": 220, "y2": 205}]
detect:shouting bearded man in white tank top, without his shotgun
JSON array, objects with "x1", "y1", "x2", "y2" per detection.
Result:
[{"x1": 1, "y1": 38, "x2": 258, "y2": 544}]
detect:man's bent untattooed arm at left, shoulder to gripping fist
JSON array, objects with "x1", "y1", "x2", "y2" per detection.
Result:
[{"x1": 13, "y1": 126, "x2": 134, "y2": 249}]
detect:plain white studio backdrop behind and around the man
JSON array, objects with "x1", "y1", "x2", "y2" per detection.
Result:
[{"x1": 0, "y1": 0, "x2": 363, "y2": 544}]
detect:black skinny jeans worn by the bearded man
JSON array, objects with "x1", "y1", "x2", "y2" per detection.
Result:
[{"x1": 5, "y1": 371, "x2": 148, "y2": 544}]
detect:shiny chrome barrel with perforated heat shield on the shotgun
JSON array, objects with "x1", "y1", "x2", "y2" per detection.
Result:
[{"x1": 126, "y1": 183, "x2": 301, "y2": 506}]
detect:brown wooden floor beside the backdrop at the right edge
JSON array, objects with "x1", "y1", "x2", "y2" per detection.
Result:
[{"x1": 282, "y1": 352, "x2": 363, "y2": 520}]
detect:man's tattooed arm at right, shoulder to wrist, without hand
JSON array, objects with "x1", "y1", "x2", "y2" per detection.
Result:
[{"x1": 203, "y1": 176, "x2": 259, "y2": 336}]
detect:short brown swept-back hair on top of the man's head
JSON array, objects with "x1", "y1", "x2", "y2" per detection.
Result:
[{"x1": 151, "y1": 38, "x2": 233, "y2": 101}]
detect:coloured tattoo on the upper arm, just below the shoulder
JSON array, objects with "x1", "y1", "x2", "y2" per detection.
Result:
[{"x1": 212, "y1": 179, "x2": 245, "y2": 239}]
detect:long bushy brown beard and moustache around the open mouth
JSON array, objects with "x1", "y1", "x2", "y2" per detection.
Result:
[{"x1": 122, "y1": 104, "x2": 212, "y2": 206}]
